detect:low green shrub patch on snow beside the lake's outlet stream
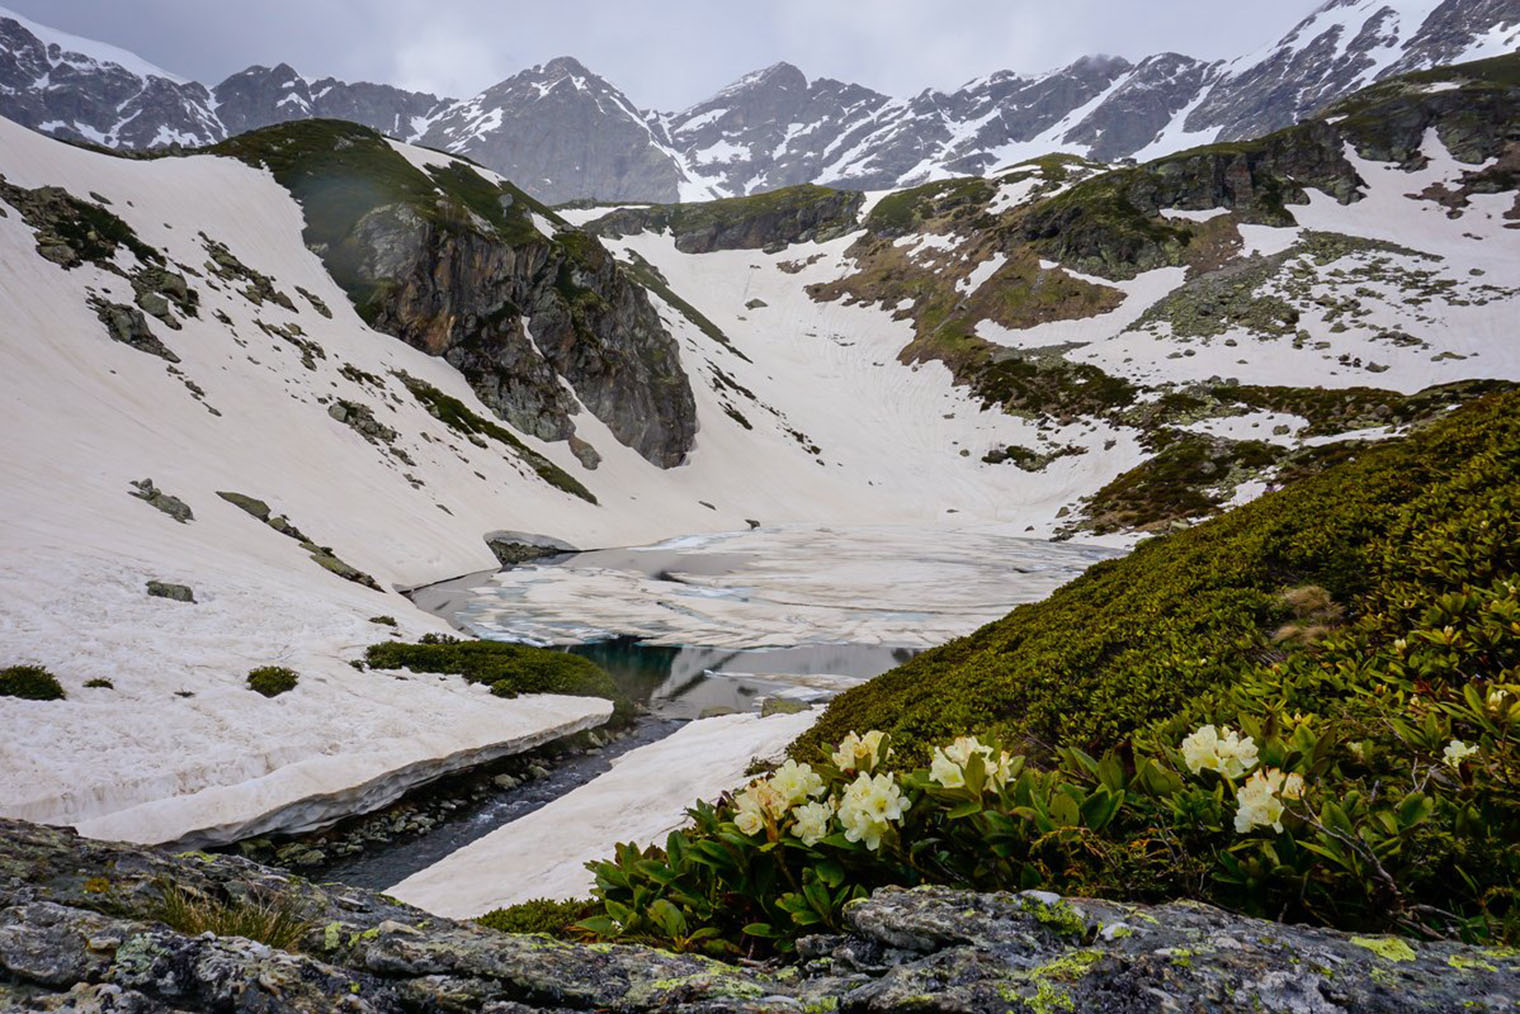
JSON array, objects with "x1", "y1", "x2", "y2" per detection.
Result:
[{"x1": 365, "y1": 634, "x2": 634, "y2": 721}]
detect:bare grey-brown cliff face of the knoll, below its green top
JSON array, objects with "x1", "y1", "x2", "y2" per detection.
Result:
[{"x1": 345, "y1": 205, "x2": 696, "y2": 468}]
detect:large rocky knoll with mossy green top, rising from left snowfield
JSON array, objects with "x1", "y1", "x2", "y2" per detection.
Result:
[{"x1": 217, "y1": 120, "x2": 696, "y2": 468}]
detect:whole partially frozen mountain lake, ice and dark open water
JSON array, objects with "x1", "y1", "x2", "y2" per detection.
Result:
[{"x1": 416, "y1": 526, "x2": 1116, "y2": 718}]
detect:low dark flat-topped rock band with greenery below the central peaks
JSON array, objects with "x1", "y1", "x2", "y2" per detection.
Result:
[{"x1": 587, "y1": 184, "x2": 865, "y2": 254}]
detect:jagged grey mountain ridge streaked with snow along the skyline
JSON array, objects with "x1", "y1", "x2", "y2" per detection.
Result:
[{"x1": 0, "y1": 0, "x2": 1520, "y2": 204}]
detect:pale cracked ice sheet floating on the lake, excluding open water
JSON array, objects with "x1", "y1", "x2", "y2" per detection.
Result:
[{"x1": 454, "y1": 526, "x2": 1113, "y2": 648}]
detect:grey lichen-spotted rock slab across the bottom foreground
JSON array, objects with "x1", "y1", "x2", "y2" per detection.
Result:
[{"x1": 0, "y1": 821, "x2": 1520, "y2": 1014}]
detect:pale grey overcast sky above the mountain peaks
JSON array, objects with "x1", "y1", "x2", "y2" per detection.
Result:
[{"x1": 0, "y1": 0, "x2": 1319, "y2": 109}]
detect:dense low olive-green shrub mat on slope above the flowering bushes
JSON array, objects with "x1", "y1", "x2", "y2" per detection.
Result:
[{"x1": 793, "y1": 386, "x2": 1520, "y2": 762}]
